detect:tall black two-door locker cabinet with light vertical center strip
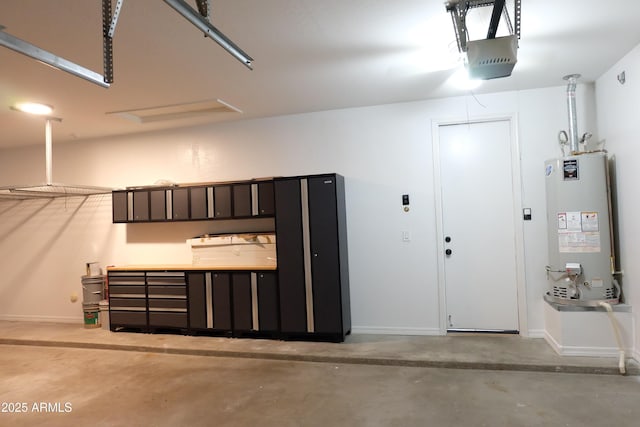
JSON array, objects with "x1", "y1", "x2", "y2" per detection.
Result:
[{"x1": 275, "y1": 174, "x2": 351, "y2": 341}]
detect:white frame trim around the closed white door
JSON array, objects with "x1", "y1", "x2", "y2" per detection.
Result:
[{"x1": 431, "y1": 113, "x2": 529, "y2": 337}]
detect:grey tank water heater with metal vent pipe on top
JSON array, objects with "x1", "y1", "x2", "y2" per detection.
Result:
[{"x1": 545, "y1": 74, "x2": 620, "y2": 306}]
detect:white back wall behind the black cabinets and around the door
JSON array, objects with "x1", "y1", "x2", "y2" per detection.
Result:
[{"x1": 0, "y1": 84, "x2": 595, "y2": 336}]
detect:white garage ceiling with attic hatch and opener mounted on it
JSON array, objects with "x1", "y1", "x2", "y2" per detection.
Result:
[{"x1": 0, "y1": 0, "x2": 640, "y2": 148}]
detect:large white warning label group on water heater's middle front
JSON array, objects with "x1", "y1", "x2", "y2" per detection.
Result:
[{"x1": 558, "y1": 212, "x2": 600, "y2": 253}]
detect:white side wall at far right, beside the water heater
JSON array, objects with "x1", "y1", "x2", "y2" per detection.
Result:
[{"x1": 596, "y1": 41, "x2": 640, "y2": 360}]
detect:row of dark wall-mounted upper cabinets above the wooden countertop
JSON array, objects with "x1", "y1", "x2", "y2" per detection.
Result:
[{"x1": 112, "y1": 180, "x2": 275, "y2": 223}]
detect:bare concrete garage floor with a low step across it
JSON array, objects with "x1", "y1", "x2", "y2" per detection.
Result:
[{"x1": 0, "y1": 322, "x2": 640, "y2": 427}]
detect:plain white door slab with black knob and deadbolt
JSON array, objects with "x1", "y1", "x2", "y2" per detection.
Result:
[{"x1": 439, "y1": 120, "x2": 519, "y2": 331}]
